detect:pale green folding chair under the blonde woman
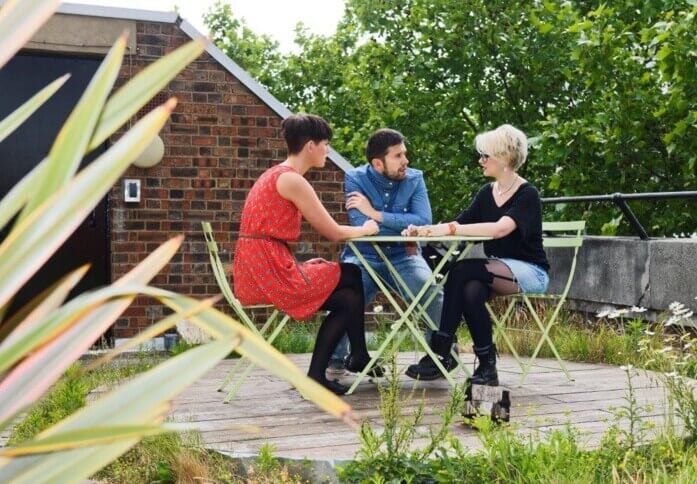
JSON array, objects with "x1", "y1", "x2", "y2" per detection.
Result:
[{"x1": 487, "y1": 220, "x2": 586, "y2": 385}]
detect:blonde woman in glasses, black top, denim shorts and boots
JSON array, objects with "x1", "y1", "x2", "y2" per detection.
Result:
[{"x1": 402, "y1": 124, "x2": 549, "y2": 386}]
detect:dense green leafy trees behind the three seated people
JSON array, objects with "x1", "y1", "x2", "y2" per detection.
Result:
[{"x1": 207, "y1": 0, "x2": 697, "y2": 235}]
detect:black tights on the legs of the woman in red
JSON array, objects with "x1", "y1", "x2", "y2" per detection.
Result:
[{"x1": 307, "y1": 263, "x2": 370, "y2": 380}]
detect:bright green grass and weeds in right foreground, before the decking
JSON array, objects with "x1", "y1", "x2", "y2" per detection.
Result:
[{"x1": 339, "y1": 355, "x2": 697, "y2": 484}]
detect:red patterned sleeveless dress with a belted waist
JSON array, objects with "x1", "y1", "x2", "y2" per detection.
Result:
[{"x1": 232, "y1": 165, "x2": 341, "y2": 320}]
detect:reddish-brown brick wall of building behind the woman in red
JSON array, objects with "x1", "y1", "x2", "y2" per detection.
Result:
[{"x1": 109, "y1": 22, "x2": 346, "y2": 338}]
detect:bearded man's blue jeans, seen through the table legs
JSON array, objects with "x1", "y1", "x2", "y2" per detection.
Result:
[{"x1": 331, "y1": 254, "x2": 443, "y2": 363}]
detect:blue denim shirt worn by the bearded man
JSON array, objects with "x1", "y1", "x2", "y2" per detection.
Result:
[{"x1": 341, "y1": 165, "x2": 431, "y2": 260}]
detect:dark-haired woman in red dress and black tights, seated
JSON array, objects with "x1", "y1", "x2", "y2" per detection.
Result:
[{"x1": 232, "y1": 114, "x2": 382, "y2": 395}]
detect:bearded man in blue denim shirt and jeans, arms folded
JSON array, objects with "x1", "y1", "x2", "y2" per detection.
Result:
[{"x1": 329, "y1": 129, "x2": 443, "y2": 374}]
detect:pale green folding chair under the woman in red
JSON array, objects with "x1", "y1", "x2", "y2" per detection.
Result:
[{"x1": 201, "y1": 222, "x2": 290, "y2": 403}]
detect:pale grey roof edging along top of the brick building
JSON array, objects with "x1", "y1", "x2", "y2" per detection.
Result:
[{"x1": 55, "y1": 1, "x2": 353, "y2": 172}]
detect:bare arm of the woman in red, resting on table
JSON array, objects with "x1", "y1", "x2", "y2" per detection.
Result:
[{"x1": 276, "y1": 172, "x2": 378, "y2": 242}]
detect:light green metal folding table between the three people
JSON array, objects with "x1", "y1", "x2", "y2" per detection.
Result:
[{"x1": 347, "y1": 235, "x2": 491, "y2": 394}]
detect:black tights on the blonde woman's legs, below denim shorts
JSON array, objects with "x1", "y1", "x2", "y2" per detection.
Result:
[{"x1": 440, "y1": 259, "x2": 519, "y2": 348}]
